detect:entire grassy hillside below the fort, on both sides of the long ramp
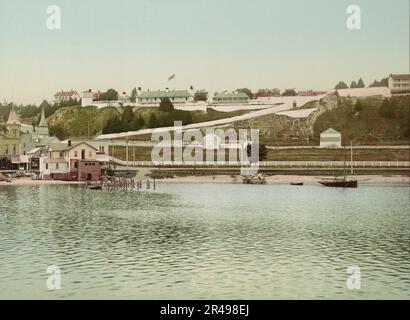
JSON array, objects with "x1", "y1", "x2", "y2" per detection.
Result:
[{"x1": 43, "y1": 96, "x2": 410, "y2": 145}]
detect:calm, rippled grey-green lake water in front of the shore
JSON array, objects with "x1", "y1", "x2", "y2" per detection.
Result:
[{"x1": 0, "y1": 184, "x2": 410, "y2": 299}]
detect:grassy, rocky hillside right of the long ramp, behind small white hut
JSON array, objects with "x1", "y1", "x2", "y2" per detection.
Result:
[{"x1": 234, "y1": 96, "x2": 410, "y2": 145}]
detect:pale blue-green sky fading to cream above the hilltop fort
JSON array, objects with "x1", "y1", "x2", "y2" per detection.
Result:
[{"x1": 0, "y1": 0, "x2": 409, "y2": 103}]
